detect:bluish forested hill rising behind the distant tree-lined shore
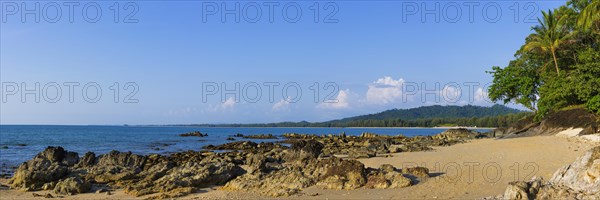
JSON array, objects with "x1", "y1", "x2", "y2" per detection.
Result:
[{"x1": 330, "y1": 104, "x2": 523, "y2": 122}]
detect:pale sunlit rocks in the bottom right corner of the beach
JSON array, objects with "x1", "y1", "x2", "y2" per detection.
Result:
[{"x1": 502, "y1": 146, "x2": 600, "y2": 199}]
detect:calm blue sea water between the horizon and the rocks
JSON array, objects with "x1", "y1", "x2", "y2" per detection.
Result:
[{"x1": 0, "y1": 125, "x2": 492, "y2": 173}]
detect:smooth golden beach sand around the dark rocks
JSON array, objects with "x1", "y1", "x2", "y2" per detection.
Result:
[{"x1": 0, "y1": 136, "x2": 599, "y2": 199}]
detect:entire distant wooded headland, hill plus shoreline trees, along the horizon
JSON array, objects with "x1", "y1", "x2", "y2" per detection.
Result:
[{"x1": 196, "y1": 105, "x2": 531, "y2": 127}]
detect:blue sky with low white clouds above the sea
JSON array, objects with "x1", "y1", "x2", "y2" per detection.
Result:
[{"x1": 0, "y1": 1, "x2": 564, "y2": 124}]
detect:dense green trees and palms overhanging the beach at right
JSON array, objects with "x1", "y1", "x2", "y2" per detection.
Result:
[{"x1": 489, "y1": 0, "x2": 600, "y2": 120}]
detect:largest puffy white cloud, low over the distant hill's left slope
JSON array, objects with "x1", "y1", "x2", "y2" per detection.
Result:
[{"x1": 367, "y1": 76, "x2": 404, "y2": 104}]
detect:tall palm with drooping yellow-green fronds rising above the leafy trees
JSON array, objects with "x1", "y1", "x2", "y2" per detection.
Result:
[{"x1": 524, "y1": 10, "x2": 570, "y2": 75}]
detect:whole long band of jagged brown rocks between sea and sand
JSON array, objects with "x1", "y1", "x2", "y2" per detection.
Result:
[{"x1": 10, "y1": 130, "x2": 460, "y2": 198}]
